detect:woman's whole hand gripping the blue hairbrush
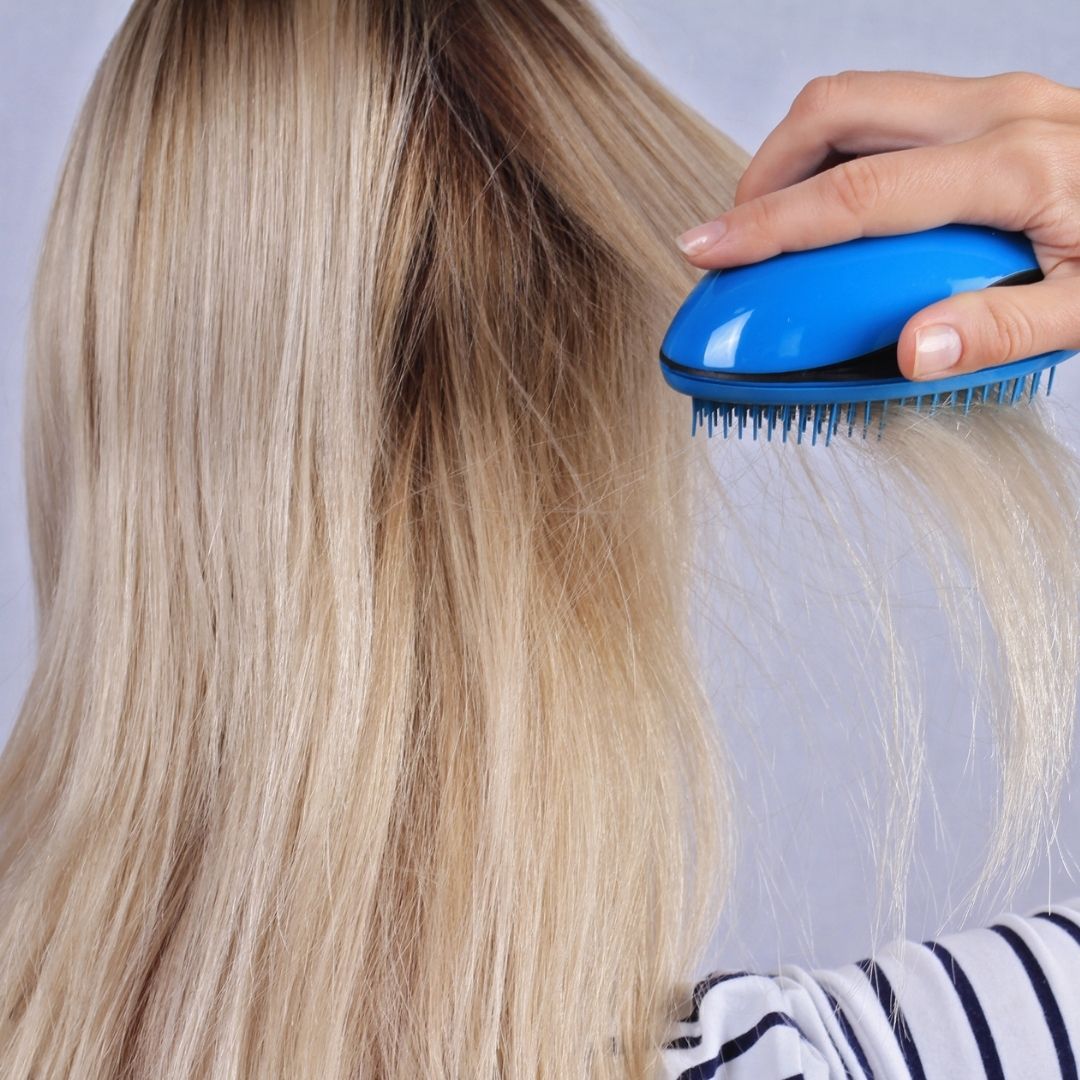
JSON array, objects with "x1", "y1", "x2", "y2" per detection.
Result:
[{"x1": 678, "y1": 71, "x2": 1080, "y2": 378}]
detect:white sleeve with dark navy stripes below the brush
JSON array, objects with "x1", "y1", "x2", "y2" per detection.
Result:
[{"x1": 661, "y1": 899, "x2": 1080, "y2": 1080}]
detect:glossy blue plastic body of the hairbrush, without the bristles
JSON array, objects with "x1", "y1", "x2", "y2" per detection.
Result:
[{"x1": 661, "y1": 224, "x2": 1075, "y2": 404}]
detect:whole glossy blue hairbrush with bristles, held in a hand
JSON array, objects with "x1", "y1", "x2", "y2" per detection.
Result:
[{"x1": 660, "y1": 225, "x2": 1077, "y2": 445}]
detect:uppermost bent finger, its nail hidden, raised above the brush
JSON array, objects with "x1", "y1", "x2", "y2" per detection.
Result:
[{"x1": 734, "y1": 71, "x2": 1080, "y2": 206}]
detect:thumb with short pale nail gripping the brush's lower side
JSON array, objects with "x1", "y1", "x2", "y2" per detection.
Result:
[{"x1": 896, "y1": 276, "x2": 1080, "y2": 379}]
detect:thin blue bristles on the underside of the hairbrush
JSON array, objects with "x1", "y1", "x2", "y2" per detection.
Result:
[{"x1": 690, "y1": 365, "x2": 1056, "y2": 446}]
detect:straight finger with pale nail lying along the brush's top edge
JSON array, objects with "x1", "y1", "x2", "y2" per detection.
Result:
[{"x1": 678, "y1": 120, "x2": 1049, "y2": 269}]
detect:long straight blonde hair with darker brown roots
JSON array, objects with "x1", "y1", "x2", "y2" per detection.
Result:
[{"x1": 0, "y1": 0, "x2": 1075, "y2": 1080}]
